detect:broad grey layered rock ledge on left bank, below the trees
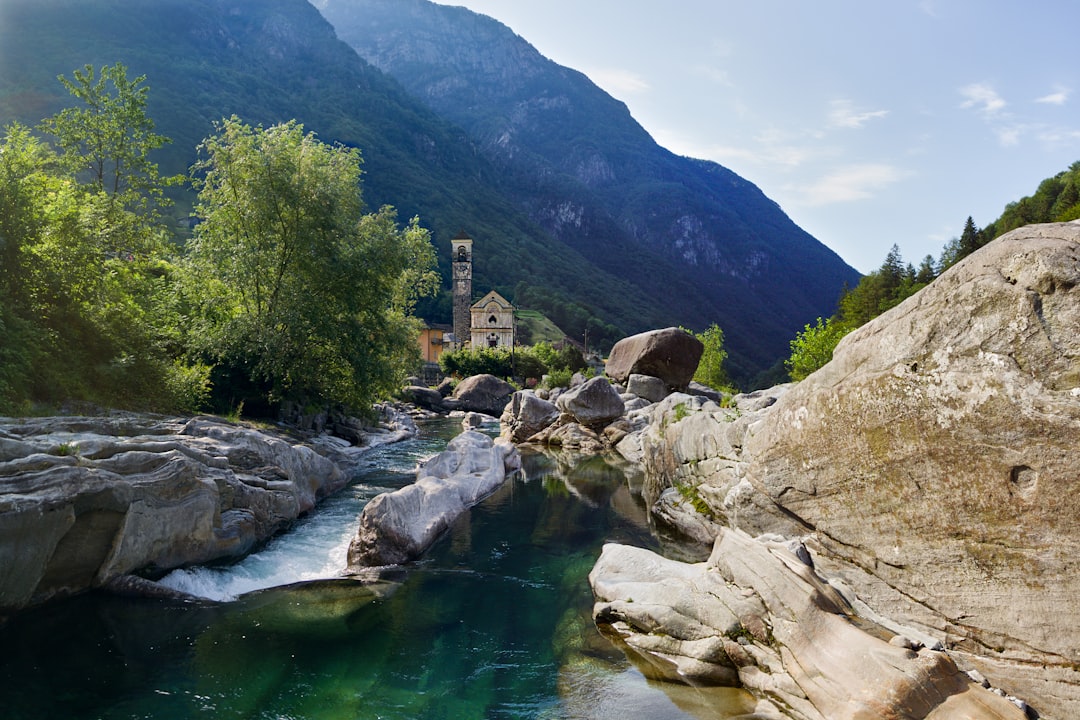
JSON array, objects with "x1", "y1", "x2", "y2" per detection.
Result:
[{"x1": 0, "y1": 413, "x2": 414, "y2": 614}]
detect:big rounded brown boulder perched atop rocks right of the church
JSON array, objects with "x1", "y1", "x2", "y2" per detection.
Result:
[{"x1": 605, "y1": 327, "x2": 704, "y2": 390}]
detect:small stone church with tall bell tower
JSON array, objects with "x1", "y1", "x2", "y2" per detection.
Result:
[{"x1": 450, "y1": 231, "x2": 514, "y2": 349}]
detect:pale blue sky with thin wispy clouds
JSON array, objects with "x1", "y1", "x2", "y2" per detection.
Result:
[{"x1": 429, "y1": 0, "x2": 1080, "y2": 273}]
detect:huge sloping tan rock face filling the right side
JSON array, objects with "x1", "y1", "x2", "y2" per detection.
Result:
[{"x1": 623, "y1": 222, "x2": 1080, "y2": 719}]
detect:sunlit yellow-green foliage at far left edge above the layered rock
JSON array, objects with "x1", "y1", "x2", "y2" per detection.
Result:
[{"x1": 0, "y1": 66, "x2": 194, "y2": 416}]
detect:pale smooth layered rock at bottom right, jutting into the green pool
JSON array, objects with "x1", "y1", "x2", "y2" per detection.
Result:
[{"x1": 589, "y1": 529, "x2": 1026, "y2": 720}]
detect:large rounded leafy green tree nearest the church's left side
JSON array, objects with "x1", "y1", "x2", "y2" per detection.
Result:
[{"x1": 184, "y1": 117, "x2": 437, "y2": 409}]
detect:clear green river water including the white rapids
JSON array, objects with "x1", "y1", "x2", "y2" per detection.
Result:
[{"x1": 0, "y1": 423, "x2": 753, "y2": 720}]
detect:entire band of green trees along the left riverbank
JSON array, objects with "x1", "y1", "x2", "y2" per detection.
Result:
[{"x1": 0, "y1": 64, "x2": 438, "y2": 413}]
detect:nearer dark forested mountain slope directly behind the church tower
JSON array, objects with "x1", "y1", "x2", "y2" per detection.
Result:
[{"x1": 0, "y1": 0, "x2": 679, "y2": 349}]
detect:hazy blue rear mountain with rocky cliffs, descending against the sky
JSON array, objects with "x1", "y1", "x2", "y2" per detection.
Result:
[{"x1": 315, "y1": 0, "x2": 859, "y2": 382}]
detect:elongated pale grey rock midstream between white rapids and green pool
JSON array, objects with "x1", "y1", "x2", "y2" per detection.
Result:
[{"x1": 349, "y1": 431, "x2": 521, "y2": 572}]
